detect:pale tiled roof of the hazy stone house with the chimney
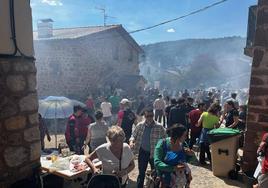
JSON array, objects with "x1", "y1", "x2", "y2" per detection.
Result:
[{"x1": 33, "y1": 25, "x2": 120, "y2": 40}]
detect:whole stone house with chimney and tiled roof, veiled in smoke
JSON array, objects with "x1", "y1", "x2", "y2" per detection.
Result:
[{"x1": 34, "y1": 23, "x2": 143, "y2": 100}]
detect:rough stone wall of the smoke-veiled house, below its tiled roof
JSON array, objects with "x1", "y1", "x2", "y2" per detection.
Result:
[{"x1": 34, "y1": 28, "x2": 139, "y2": 99}]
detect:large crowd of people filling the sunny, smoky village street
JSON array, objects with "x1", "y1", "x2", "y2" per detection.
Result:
[{"x1": 38, "y1": 87, "x2": 247, "y2": 188}]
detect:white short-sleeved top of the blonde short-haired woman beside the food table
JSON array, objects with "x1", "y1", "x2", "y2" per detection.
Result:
[{"x1": 96, "y1": 143, "x2": 134, "y2": 184}]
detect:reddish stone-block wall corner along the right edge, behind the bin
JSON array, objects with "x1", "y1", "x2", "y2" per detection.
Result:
[{"x1": 242, "y1": 0, "x2": 268, "y2": 172}]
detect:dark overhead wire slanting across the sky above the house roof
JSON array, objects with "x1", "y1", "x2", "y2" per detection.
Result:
[{"x1": 128, "y1": 0, "x2": 228, "y2": 34}]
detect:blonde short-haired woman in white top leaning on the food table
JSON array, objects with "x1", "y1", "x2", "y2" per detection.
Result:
[{"x1": 86, "y1": 126, "x2": 135, "y2": 187}]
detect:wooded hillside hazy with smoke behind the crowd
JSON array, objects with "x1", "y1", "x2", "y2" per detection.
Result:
[{"x1": 140, "y1": 37, "x2": 251, "y2": 88}]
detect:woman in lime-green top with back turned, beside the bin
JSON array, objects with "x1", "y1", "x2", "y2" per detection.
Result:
[{"x1": 198, "y1": 103, "x2": 221, "y2": 165}]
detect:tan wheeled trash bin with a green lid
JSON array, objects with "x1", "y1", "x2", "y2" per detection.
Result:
[{"x1": 208, "y1": 128, "x2": 241, "y2": 177}]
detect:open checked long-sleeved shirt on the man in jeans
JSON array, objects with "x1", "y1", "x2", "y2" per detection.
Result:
[{"x1": 130, "y1": 121, "x2": 166, "y2": 158}]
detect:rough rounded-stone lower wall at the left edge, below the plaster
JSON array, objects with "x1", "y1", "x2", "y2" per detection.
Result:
[{"x1": 0, "y1": 57, "x2": 41, "y2": 187}]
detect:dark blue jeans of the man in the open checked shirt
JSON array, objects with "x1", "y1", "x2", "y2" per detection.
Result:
[{"x1": 137, "y1": 148, "x2": 154, "y2": 188}]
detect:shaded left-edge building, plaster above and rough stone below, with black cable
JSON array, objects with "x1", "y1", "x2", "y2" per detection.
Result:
[{"x1": 0, "y1": 0, "x2": 41, "y2": 188}]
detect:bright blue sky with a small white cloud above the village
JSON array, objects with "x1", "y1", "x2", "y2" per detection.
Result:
[{"x1": 31, "y1": 0, "x2": 257, "y2": 44}]
